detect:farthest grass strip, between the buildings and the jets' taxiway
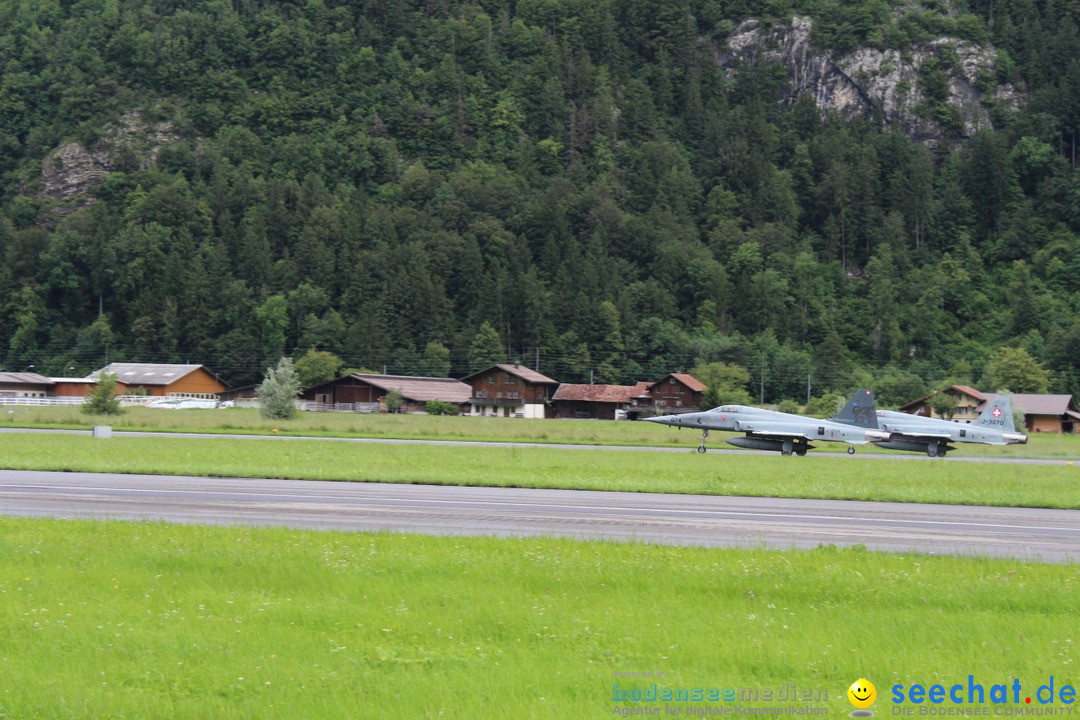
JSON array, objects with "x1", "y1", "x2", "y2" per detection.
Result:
[{"x1": 0, "y1": 407, "x2": 1080, "y2": 459}]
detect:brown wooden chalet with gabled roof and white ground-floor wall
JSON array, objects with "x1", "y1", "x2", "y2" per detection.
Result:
[{"x1": 461, "y1": 364, "x2": 558, "y2": 418}]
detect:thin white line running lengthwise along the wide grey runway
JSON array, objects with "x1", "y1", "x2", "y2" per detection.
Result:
[{"x1": 0, "y1": 484, "x2": 1080, "y2": 530}]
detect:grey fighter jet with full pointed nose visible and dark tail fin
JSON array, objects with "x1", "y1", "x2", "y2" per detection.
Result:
[{"x1": 645, "y1": 390, "x2": 889, "y2": 456}]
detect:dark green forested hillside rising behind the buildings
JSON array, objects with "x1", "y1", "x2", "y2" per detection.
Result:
[{"x1": 0, "y1": 0, "x2": 1080, "y2": 402}]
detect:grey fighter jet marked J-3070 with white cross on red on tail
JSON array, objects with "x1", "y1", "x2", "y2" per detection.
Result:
[{"x1": 835, "y1": 395, "x2": 1027, "y2": 458}]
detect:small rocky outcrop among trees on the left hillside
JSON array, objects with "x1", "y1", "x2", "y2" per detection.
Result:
[{"x1": 41, "y1": 110, "x2": 179, "y2": 216}]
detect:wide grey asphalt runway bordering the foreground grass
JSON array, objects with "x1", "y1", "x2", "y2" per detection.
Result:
[{"x1": 0, "y1": 471, "x2": 1080, "y2": 562}]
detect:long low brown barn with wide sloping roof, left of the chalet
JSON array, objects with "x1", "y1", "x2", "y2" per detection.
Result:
[{"x1": 301, "y1": 372, "x2": 472, "y2": 412}]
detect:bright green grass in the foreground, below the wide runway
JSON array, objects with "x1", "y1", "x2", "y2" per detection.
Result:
[{"x1": 0, "y1": 519, "x2": 1080, "y2": 720}]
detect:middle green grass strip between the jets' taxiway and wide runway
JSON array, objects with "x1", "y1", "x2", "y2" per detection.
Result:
[{"x1": 0, "y1": 434, "x2": 1080, "y2": 508}]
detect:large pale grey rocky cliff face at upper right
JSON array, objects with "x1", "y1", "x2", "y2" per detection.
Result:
[{"x1": 715, "y1": 16, "x2": 1020, "y2": 140}]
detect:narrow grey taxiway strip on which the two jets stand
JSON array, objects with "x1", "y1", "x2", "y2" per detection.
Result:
[{"x1": 0, "y1": 427, "x2": 1080, "y2": 465}]
